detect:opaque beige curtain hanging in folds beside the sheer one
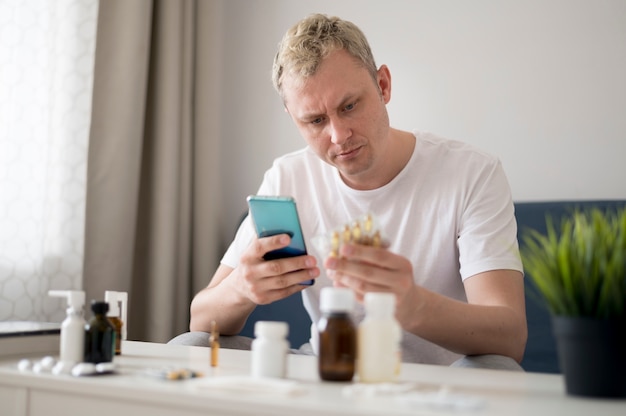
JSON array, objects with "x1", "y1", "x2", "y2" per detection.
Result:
[{"x1": 83, "y1": 0, "x2": 221, "y2": 342}]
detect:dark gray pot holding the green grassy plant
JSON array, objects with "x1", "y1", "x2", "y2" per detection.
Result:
[{"x1": 552, "y1": 316, "x2": 626, "y2": 398}]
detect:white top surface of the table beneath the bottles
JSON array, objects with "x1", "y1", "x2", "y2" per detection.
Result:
[{"x1": 0, "y1": 341, "x2": 626, "y2": 416}]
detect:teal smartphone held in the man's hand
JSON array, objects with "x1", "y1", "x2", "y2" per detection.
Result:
[{"x1": 247, "y1": 195, "x2": 313, "y2": 285}]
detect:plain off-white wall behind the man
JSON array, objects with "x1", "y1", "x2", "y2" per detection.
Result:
[{"x1": 216, "y1": 0, "x2": 626, "y2": 245}]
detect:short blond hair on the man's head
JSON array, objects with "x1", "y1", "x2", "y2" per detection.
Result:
[{"x1": 272, "y1": 14, "x2": 377, "y2": 96}]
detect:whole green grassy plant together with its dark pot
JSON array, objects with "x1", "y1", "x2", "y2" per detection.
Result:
[{"x1": 521, "y1": 208, "x2": 626, "y2": 397}]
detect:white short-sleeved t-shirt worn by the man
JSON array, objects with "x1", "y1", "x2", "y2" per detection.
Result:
[{"x1": 222, "y1": 132, "x2": 522, "y2": 365}]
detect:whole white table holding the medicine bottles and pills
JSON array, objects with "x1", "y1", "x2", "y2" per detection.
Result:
[{"x1": 0, "y1": 341, "x2": 626, "y2": 416}]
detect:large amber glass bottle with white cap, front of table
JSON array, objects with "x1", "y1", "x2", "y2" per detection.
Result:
[{"x1": 317, "y1": 287, "x2": 356, "y2": 381}]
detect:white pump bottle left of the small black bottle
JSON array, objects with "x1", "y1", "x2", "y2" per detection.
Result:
[{"x1": 48, "y1": 290, "x2": 86, "y2": 373}]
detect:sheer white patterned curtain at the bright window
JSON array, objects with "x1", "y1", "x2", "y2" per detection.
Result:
[{"x1": 0, "y1": 0, "x2": 98, "y2": 321}]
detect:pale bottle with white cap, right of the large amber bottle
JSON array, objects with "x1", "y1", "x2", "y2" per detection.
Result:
[{"x1": 357, "y1": 292, "x2": 402, "y2": 383}]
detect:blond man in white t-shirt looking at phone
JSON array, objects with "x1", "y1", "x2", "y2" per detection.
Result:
[{"x1": 190, "y1": 15, "x2": 527, "y2": 369}]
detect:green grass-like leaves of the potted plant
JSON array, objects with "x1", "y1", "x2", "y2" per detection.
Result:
[{"x1": 521, "y1": 208, "x2": 626, "y2": 318}]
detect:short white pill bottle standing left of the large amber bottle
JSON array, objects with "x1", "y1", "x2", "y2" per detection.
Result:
[{"x1": 251, "y1": 321, "x2": 289, "y2": 378}]
